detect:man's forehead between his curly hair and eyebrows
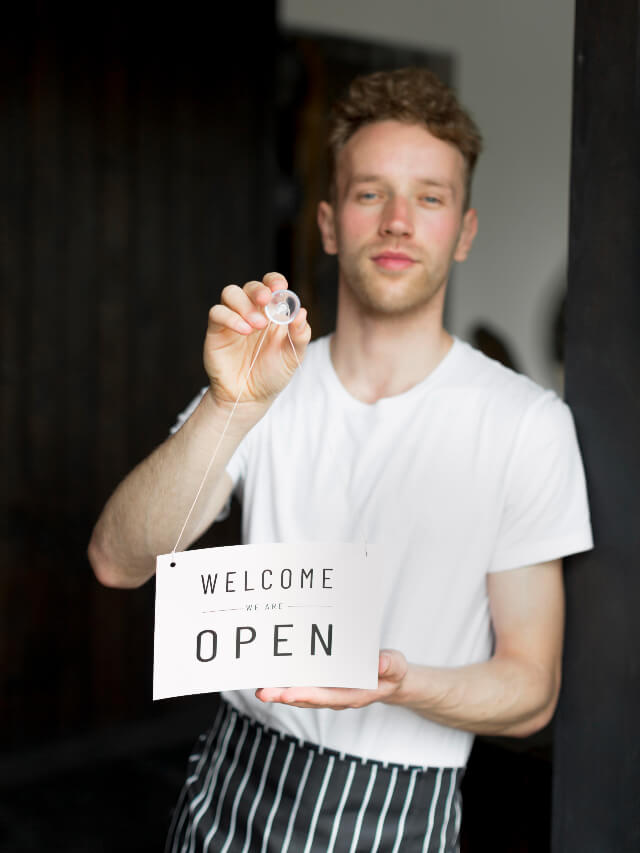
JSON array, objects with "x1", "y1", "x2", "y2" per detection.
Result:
[{"x1": 336, "y1": 121, "x2": 466, "y2": 192}]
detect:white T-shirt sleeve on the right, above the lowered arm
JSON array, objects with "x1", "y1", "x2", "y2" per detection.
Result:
[{"x1": 489, "y1": 392, "x2": 593, "y2": 572}]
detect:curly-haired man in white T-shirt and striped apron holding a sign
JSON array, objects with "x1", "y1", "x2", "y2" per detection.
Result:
[{"x1": 90, "y1": 69, "x2": 591, "y2": 853}]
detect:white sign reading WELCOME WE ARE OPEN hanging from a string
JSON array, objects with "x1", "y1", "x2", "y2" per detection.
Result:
[{"x1": 153, "y1": 543, "x2": 383, "y2": 699}]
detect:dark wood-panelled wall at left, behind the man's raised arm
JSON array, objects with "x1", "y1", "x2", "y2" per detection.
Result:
[{"x1": 0, "y1": 2, "x2": 275, "y2": 747}]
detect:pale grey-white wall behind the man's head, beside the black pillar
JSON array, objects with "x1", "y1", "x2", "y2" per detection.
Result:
[{"x1": 280, "y1": 0, "x2": 573, "y2": 386}]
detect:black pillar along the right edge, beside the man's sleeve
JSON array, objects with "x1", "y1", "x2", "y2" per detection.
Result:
[{"x1": 553, "y1": 0, "x2": 640, "y2": 853}]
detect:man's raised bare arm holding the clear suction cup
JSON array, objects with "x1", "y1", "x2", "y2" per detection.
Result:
[{"x1": 88, "y1": 273, "x2": 311, "y2": 587}]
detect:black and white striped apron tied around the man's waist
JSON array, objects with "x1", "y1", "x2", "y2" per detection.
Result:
[{"x1": 166, "y1": 702, "x2": 463, "y2": 853}]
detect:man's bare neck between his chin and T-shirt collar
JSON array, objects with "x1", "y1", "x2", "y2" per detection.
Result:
[{"x1": 331, "y1": 288, "x2": 453, "y2": 403}]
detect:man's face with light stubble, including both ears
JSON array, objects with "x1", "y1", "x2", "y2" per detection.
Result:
[{"x1": 318, "y1": 121, "x2": 477, "y2": 315}]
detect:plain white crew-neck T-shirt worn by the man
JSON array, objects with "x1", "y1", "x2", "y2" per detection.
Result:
[{"x1": 176, "y1": 338, "x2": 592, "y2": 767}]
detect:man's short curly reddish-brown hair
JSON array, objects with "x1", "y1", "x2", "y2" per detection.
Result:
[{"x1": 328, "y1": 68, "x2": 482, "y2": 208}]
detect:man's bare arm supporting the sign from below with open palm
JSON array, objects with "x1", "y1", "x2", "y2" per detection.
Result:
[{"x1": 256, "y1": 560, "x2": 564, "y2": 737}]
